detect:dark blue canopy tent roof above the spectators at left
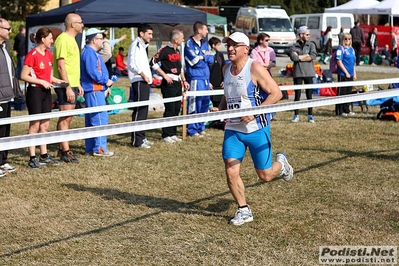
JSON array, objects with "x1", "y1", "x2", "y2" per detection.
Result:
[{"x1": 26, "y1": 0, "x2": 207, "y2": 28}]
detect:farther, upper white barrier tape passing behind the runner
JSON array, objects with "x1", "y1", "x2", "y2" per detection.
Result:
[{"x1": 0, "y1": 78, "x2": 399, "y2": 125}]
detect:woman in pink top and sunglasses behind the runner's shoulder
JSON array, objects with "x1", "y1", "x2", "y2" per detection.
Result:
[{"x1": 251, "y1": 32, "x2": 276, "y2": 76}]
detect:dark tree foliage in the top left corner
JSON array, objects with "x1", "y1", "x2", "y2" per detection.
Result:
[{"x1": 0, "y1": 0, "x2": 49, "y2": 21}]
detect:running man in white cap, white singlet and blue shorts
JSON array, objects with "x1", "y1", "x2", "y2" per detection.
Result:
[{"x1": 211, "y1": 32, "x2": 294, "y2": 226}]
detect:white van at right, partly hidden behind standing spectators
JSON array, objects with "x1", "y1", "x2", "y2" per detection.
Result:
[{"x1": 290, "y1": 13, "x2": 355, "y2": 50}]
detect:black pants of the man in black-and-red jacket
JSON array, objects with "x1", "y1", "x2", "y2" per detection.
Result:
[{"x1": 161, "y1": 79, "x2": 182, "y2": 138}]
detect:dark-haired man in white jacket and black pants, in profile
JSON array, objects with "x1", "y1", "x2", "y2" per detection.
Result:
[{"x1": 128, "y1": 24, "x2": 153, "y2": 149}]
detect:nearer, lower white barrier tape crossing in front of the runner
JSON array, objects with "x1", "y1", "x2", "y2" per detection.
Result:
[{"x1": 0, "y1": 90, "x2": 399, "y2": 150}]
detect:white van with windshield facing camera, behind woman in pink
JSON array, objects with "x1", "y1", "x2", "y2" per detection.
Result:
[{"x1": 235, "y1": 6, "x2": 296, "y2": 54}]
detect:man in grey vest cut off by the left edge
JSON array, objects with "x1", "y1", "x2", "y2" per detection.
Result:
[{"x1": 0, "y1": 18, "x2": 20, "y2": 177}]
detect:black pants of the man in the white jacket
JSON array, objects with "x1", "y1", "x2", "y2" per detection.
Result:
[{"x1": 131, "y1": 81, "x2": 150, "y2": 147}]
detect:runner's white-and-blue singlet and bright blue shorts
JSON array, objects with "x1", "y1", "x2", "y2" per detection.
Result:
[{"x1": 222, "y1": 58, "x2": 273, "y2": 170}]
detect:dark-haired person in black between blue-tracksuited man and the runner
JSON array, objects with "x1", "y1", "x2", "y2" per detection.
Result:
[{"x1": 209, "y1": 37, "x2": 226, "y2": 106}]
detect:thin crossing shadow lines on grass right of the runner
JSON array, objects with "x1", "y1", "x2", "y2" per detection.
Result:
[{"x1": 295, "y1": 148, "x2": 399, "y2": 174}]
